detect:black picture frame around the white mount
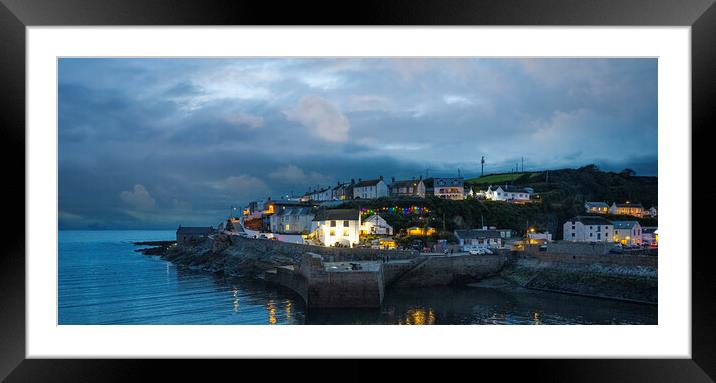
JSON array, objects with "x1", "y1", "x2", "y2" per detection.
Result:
[{"x1": 0, "y1": 0, "x2": 716, "y2": 382}]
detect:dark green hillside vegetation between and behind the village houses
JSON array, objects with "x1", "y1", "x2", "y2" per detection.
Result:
[{"x1": 343, "y1": 166, "x2": 658, "y2": 239}]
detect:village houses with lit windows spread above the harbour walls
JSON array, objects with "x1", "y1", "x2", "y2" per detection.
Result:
[{"x1": 177, "y1": 170, "x2": 658, "y2": 255}]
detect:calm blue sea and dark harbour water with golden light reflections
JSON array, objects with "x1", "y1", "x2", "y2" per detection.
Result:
[{"x1": 58, "y1": 231, "x2": 657, "y2": 324}]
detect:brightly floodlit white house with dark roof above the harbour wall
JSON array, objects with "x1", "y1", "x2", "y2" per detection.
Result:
[{"x1": 311, "y1": 209, "x2": 361, "y2": 247}]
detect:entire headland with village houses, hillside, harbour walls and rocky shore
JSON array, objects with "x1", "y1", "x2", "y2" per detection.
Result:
[{"x1": 165, "y1": 165, "x2": 659, "y2": 308}]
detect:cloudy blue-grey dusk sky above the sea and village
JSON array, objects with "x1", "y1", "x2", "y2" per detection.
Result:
[{"x1": 58, "y1": 58, "x2": 658, "y2": 229}]
